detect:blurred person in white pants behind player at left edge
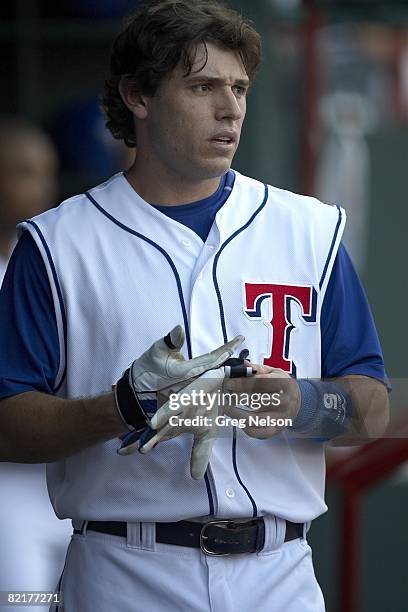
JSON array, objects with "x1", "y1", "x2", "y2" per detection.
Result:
[{"x1": 0, "y1": 116, "x2": 71, "y2": 611}]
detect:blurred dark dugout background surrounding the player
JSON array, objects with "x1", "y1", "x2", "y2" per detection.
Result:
[{"x1": 0, "y1": 0, "x2": 408, "y2": 612}]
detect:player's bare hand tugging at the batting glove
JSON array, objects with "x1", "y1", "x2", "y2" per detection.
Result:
[{"x1": 223, "y1": 362, "x2": 301, "y2": 440}]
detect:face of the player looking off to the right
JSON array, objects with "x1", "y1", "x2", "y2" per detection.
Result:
[{"x1": 140, "y1": 43, "x2": 249, "y2": 181}]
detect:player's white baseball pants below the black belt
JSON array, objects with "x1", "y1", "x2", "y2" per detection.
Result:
[{"x1": 52, "y1": 517, "x2": 325, "y2": 612}]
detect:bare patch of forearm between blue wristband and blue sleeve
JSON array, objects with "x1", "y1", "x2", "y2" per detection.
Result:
[{"x1": 330, "y1": 376, "x2": 389, "y2": 446}]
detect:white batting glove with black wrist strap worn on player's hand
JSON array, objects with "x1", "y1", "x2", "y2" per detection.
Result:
[{"x1": 115, "y1": 325, "x2": 244, "y2": 462}]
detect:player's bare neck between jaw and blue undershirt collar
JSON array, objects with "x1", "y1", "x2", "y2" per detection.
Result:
[{"x1": 126, "y1": 151, "x2": 220, "y2": 206}]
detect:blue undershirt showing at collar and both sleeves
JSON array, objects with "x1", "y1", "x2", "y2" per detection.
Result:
[{"x1": 0, "y1": 172, "x2": 387, "y2": 398}]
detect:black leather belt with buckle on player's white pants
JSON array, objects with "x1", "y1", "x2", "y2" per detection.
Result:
[{"x1": 74, "y1": 517, "x2": 303, "y2": 556}]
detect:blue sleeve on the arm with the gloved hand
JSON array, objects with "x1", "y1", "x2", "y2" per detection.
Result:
[{"x1": 0, "y1": 232, "x2": 60, "y2": 398}]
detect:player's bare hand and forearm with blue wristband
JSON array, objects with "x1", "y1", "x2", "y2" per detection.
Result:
[{"x1": 224, "y1": 365, "x2": 389, "y2": 446}]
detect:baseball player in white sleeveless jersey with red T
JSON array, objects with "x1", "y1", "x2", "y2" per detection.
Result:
[{"x1": 0, "y1": 0, "x2": 388, "y2": 612}]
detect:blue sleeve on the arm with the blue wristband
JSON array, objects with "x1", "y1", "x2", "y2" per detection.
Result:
[{"x1": 321, "y1": 245, "x2": 388, "y2": 385}]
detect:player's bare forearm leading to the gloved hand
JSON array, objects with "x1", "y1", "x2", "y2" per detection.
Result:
[{"x1": 0, "y1": 391, "x2": 126, "y2": 463}]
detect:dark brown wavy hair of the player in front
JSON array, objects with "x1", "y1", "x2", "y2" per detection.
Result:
[{"x1": 102, "y1": 0, "x2": 261, "y2": 147}]
